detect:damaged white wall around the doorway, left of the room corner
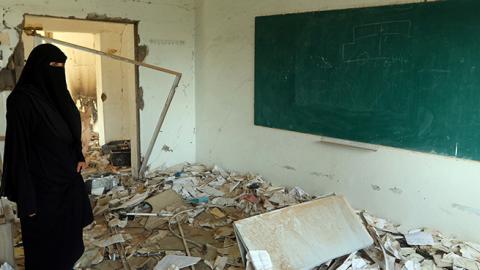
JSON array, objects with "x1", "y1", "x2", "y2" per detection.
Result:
[{"x1": 0, "y1": 0, "x2": 195, "y2": 171}]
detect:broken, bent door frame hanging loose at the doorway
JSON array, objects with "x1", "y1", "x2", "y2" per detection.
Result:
[{"x1": 23, "y1": 14, "x2": 182, "y2": 178}]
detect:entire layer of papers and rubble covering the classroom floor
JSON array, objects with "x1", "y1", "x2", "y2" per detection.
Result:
[{"x1": 6, "y1": 164, "x2": 480, "y2": 270}]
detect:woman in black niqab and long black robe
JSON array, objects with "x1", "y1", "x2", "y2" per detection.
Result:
[{"x1": 0, "y1": 44, "x2": 93, "y2": 270}]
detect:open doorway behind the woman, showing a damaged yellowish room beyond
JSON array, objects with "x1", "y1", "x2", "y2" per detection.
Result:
[{"x1": 22, "y1": 15, "x2": 140, "y2": 177}]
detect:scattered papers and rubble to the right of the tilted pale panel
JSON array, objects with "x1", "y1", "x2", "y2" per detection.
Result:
[{"x1": 317, "y1": 212, "x2": 480, "y2": 270}]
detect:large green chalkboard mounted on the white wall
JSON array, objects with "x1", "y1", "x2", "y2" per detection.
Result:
[{"x1": 255, "y1": 0, "x2": 480, "y2": 160}]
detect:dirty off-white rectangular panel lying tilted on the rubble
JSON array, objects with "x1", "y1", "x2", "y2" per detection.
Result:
[{"x1": 234, "y1": 195, "x2": 373, "y2": 269}]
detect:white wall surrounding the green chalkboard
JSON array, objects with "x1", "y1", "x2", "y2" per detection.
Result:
[{"x1": 195, "y1": 0, "x2": 480, "y2": 241}]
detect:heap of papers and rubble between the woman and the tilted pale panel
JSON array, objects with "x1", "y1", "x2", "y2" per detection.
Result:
[{"x1": 77, "y1": 164, "x2": 312, "y2": 270}]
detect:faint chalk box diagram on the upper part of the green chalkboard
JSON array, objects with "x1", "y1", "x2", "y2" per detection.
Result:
[{"x1": 341, "y1": 20, "x2": 412, "y2": 63}]
